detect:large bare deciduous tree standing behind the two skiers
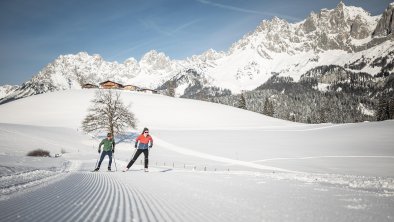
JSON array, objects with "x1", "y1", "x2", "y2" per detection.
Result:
[{"x1": 82, "y1": 90, "x2": 136, "y2": 135}]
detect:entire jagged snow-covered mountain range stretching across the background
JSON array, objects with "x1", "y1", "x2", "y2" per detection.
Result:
[{"x1": 0, "y1": 2, "x2": 394, "y2": 103}]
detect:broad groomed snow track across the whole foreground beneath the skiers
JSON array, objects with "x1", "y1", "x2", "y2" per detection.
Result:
[{"x1": 0, "y1": 161, "x2": 394, "y2": 222}]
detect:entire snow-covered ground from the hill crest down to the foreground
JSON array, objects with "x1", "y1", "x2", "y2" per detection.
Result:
[{"x1": 0, "y1": 90, "x2": 394, "y2": 221}]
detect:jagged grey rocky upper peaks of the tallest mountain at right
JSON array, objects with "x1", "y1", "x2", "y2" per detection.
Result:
[{"x1": 229, "y1": 1, "x2": 377, "y2": 55}]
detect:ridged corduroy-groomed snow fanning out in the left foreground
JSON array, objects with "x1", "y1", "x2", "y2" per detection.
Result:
[{"x1": 0, "y1": 171, "x2": 208, "y2": 222}]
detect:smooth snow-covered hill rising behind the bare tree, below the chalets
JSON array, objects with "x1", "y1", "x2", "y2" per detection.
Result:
[{"x1": 0, "y1": 89, "x2": 298, "y2": 129}]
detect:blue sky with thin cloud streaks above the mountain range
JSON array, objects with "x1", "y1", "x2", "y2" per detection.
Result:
[{"x1": 0, "y1": 0, "x2": 392, "y2": 85}]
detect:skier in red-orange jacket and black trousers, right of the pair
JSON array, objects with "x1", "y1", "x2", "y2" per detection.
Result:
[{"x1": 123, "y1": 128, "x2": 153, "y2": 172}]
